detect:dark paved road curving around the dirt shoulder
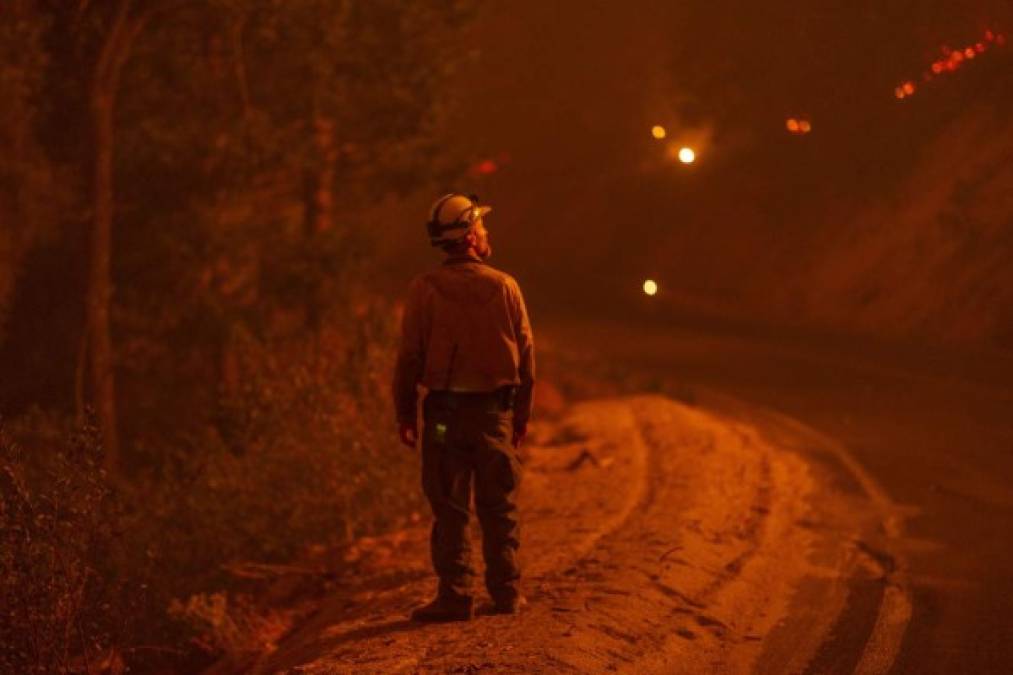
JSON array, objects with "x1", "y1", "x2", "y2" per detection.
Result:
[{"x1": 542, "y1": 312, "x2": 1013, "y2": 675}]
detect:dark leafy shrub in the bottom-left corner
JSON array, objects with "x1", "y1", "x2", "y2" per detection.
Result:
[{"x1": 0, "y1": 413, "x2": 114, "y2": 673}]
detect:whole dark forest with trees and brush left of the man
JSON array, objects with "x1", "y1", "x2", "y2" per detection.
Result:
[{"x1": 0, "y1": 0, "x2": 475, "y2": 672}]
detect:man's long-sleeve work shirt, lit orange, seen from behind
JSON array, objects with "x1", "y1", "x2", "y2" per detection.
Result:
[{"x1": 393, "y1": 257, "x2": 535, "y2": 426}]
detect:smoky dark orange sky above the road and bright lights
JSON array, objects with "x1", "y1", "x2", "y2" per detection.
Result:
[{"x1": 401, "y1": 0, "x2": 1013, "y2": 306}]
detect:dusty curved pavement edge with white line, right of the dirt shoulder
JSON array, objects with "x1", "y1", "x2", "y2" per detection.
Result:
[{"x1": 730, "y1": 404, "x2": 913, "y2": 675}]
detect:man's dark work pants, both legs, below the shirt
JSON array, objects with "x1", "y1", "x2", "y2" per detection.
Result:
[{"x1": 422, "y1": 394, "x2": 521, "y2": 602}]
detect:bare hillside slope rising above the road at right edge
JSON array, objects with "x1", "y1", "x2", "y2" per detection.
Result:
[{"x1": 801, "y1": 107, "x2": 1013, "y2": 348}]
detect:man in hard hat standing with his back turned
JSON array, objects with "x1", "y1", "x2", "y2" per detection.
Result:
[{"x1": 393, "y1": 194, "x2": 535, "y2": 621}]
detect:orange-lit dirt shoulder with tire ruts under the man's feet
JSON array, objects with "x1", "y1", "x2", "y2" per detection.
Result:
[{"x1": 243, "y1": 389, "x2": 910, "y2": 673}]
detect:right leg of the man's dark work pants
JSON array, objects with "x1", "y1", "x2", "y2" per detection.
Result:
[{"x1": 475, "y1": 413, "x2": 521, "y2": 601}]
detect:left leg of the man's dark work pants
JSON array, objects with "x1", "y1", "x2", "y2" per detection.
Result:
[{"x1": 422, "y1": 409, "x2": 475, "y2": 600}]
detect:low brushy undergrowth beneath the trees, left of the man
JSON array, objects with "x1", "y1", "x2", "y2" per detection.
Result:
[{"x1": 0, "y1": 301, "x2": 420, "y2": 672}]
